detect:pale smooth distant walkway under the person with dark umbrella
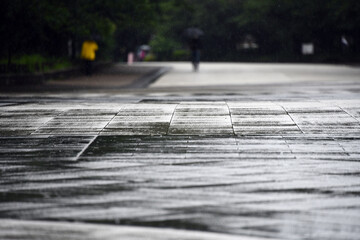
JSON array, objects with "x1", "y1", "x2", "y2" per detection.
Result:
[{"x1": 145, "y1": 63, "x2": 360, "y2": 88}]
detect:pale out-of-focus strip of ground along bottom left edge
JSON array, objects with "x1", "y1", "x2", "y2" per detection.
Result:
[{"x1": 0, "y1": 219, "x2": 256, "y2": 240}]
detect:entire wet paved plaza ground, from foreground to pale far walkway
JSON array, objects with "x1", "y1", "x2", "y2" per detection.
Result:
[{"x1": 0, "y1": 63, "x2": 360, "y2": 240}]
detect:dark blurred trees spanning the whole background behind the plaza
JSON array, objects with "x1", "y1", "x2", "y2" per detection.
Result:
[{"x1": 0, "y1": 0, "x2": 360, "y2": 73}]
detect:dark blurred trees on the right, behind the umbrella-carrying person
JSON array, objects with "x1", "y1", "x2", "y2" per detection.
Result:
[{"x1": 152, "y1": 0, "x2": 360, "y2": 61}]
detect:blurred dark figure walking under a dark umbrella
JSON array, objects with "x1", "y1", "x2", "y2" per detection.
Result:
[{"x1": 185, "y1": 27, "x2": 204, "y2": 72}]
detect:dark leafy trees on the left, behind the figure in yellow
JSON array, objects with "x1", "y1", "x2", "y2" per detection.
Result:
[{"x1": 0, "y1": 0, "x2": 157, "y2": 64}]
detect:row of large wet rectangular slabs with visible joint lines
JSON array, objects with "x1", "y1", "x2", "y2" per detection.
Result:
[{"x1": 4, "y1": 101, "x2": 360, "y2": 136}]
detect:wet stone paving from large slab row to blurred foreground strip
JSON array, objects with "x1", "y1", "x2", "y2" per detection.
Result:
[{"x1": 0, "y1": 100, "x2": 360, "y2": 239}]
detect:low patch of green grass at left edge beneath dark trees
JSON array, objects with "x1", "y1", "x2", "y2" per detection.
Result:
[{"x1": 0, "y1": 54, "x2": 73, "y2": 73}]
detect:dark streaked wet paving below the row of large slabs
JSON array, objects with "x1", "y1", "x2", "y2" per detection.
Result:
[{"x1": 0, "y1": 135, "x2": 360, "y2": 239}]
